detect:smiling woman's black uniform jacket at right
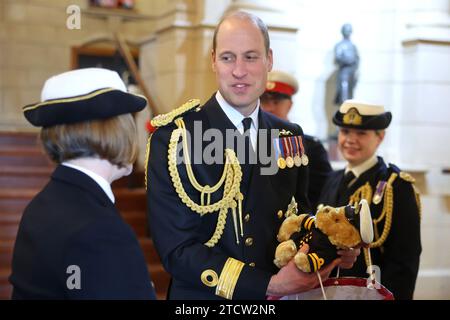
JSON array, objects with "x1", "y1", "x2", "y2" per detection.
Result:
[{"x1": 320, "y1": 157, "x2": 422, "y2": 300}]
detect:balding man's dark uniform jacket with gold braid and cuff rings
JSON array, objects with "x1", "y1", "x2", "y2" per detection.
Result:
[{"x1": 147, "y1": 97, "x2": 309, "y2": 299}]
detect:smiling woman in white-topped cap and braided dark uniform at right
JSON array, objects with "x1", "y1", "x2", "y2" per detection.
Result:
[{"x1": 320, "y1": 100, "x2": 422, "y2": 300}]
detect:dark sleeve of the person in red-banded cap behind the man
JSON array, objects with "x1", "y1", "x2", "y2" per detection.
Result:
[{"x1": 303, "y1": 134, "x2": 333, "y2": 210}]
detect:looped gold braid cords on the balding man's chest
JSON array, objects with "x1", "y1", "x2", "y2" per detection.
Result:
[{"x1": 168, "y1": 118, "x2": 243, "y2": 247}]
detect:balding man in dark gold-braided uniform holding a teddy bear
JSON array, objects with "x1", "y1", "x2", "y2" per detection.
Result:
[{"x1": 147, "y1": 12, "x2": 359, "y2": 299}]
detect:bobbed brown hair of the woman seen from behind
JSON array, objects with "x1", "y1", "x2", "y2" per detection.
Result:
[{"x1": 40, "y1": 114, "x2": 138, "y2": 167}]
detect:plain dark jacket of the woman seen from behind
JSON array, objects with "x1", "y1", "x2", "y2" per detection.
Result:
[{"x1": 10, "y1": 165, "x2": 155, "y2": 300}]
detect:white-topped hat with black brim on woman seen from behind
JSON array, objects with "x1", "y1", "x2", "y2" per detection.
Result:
[{"x1": 23, "y1": 68, "x2": 147, "y2": 127}]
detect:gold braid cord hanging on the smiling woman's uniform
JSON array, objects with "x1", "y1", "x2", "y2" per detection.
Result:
[{"x1": 364, "y1": 173, "x2": 398, "y2": 266}]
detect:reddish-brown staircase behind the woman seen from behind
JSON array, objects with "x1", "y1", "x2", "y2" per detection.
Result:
[{"x1": 0, "y1": 132, "x2": 170, "y2": 299}]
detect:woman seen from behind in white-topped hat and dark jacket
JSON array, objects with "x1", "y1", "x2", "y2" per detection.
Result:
[{"x1": 9, "y1": 68, "x2": 155, "y2": 300}]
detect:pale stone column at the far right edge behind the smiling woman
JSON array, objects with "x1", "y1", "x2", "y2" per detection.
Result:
[{"x1": 394, "y1": 5, "x2": 450, "y2": 299}]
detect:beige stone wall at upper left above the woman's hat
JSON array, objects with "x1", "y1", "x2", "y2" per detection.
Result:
[{"x1": 0, "y1": 0, "x2": 156, "y2": 131}]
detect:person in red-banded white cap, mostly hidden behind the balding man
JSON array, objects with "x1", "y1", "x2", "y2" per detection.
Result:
[{"x1": 261, "y1": 71, "x2": 332, "y2": 209}]
